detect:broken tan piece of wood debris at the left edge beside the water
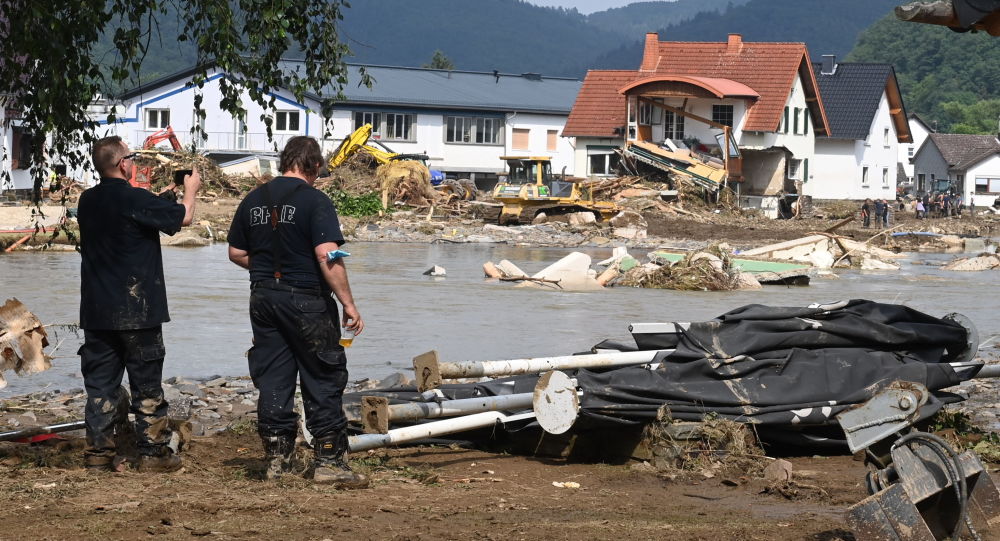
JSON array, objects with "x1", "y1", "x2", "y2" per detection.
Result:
[{"x1": 0, "y1": 299, "x2": 52, "y2": 389}]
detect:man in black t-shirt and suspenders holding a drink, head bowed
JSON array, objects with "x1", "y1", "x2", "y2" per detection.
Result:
[{"x1": 229, "y1": 136, "x2": 368, "y2": 488}]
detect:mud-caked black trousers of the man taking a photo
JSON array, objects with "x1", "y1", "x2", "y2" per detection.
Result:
[{"x1": 79, "y1": 326, "x2": 171, "y2": 455}]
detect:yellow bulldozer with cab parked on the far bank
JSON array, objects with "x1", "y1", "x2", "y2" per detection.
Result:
[{"x1": 493, "y1": 156, "x2": 621, "y2": 225}]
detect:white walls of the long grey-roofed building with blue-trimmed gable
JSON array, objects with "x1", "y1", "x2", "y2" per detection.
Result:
[{"x1": 99, "y1": 67, "x2": 573, "y2": 174}]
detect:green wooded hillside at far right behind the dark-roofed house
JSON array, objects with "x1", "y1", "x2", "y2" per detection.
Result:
[{"x1": 847, "y1": 11, "x2": 1000, "y2": 134}]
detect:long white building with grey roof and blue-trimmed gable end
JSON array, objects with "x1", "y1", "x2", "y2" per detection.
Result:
[{"x1": 102, "y1": 61, "x2": 580, "y2": 186}]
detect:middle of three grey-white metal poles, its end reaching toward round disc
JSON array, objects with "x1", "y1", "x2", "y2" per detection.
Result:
[{"x1": 361, "y1": 393, "x2": 532, "y2": 434}]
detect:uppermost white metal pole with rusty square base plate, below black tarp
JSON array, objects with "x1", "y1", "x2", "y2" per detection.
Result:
[{"x1": 413, "y1": 349, "x2": 674, "y2": 391}]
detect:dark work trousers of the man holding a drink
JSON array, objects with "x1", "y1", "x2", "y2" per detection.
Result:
[{"x1": 248, "y1": 281, "x2": 347, "y2": 438}]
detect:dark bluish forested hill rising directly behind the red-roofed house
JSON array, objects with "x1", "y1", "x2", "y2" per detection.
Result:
[{"x1": 591, "y1": 0, "x2": 901, "y2": 69}]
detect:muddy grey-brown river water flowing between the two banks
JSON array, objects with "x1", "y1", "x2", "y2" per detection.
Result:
[{"x1": 0, "y1": 243, "x2": 1000, "y2": 398}]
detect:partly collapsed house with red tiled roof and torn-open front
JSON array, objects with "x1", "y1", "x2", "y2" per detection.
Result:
[{"x1": 563, "y1": 33, "x2": 830, "y2": 206}]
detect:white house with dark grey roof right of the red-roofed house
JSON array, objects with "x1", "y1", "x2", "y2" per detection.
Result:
[{"x1": 804, "y1": 55, "x2": 911, "y2": 200}]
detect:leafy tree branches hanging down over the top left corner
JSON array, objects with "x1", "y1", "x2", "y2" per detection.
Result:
[{"x1": 0, "y1": 0, "x2": 370, "y2": 200}]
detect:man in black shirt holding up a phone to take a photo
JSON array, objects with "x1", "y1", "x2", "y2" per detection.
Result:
[{"x1": 78, "y1": 137, "x2": 201, "y2": 471}]
